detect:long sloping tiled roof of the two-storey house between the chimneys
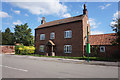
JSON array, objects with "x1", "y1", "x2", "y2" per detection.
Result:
[{"x1": 36, "y1": 15, "x2": 84, "y2": 29}]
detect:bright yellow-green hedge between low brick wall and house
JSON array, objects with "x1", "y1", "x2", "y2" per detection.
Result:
[{"x1": 15, "y1": 45, "x2": 35, "y2": 54}]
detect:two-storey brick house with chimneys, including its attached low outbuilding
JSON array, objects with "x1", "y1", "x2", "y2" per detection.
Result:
[{"x1": 35, "y1": 4, "x2": 119, "y2": 57}]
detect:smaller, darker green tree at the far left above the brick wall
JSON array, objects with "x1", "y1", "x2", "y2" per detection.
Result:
[{"x1": 2, "y1": 28, "x2": 14, "y2": 45}]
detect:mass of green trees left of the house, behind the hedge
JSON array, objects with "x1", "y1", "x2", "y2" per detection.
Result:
[{"x1": 2, "y1": 23, "x2": 34, "y2": 46}]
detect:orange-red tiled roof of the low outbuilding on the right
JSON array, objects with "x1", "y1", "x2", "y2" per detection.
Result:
[{"x1": 89, "y1": 33, "x2": 116, "y2": 45}]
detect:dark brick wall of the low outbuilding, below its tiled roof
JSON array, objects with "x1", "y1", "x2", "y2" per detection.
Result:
[{"x1": 85, "y1": 45, "x2": 120, "y2": 57}]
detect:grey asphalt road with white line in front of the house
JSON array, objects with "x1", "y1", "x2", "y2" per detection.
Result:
[{"x1": 0, "y1": 55, "x2": 118, "y2": 78}]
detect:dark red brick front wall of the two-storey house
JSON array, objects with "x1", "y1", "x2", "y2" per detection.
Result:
[{"x1": 35, "y1": 21, "x2": 83, "y2": 56}]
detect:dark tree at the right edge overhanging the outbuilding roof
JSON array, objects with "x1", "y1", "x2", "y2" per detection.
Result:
[{"x1": 111, "y1": 18, "x2": 120, "y2": 45}]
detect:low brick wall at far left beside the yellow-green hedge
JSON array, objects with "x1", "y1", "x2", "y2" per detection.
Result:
[{"x1": 0, "y1": 45, "x2": 15, "y2": 54}]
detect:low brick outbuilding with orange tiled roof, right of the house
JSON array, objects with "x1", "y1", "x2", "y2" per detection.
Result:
[{"x1": 85, "y1": 33, "x2": 120, "y2": 57}]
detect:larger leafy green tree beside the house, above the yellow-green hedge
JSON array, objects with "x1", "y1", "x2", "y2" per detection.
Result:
[{"x1": 14, "y1": 23, "x2": 34, "y2": 46}]
